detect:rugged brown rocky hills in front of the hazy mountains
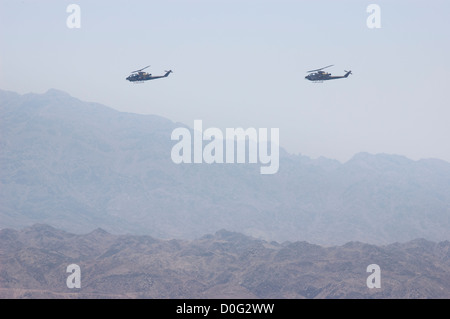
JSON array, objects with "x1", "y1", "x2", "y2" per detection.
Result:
[{"x1": 0, "y1": 224, "x2": 450, "y2": 299}]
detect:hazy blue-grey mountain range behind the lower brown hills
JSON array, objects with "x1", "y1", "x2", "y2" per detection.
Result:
[{"x1": 0, "y1": 89, "x2": 450, "y2": 245}]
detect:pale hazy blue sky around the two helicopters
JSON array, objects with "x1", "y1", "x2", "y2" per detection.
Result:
[{"x1": 0, "y1": 0, "x2": 450, "y2": 161}]
